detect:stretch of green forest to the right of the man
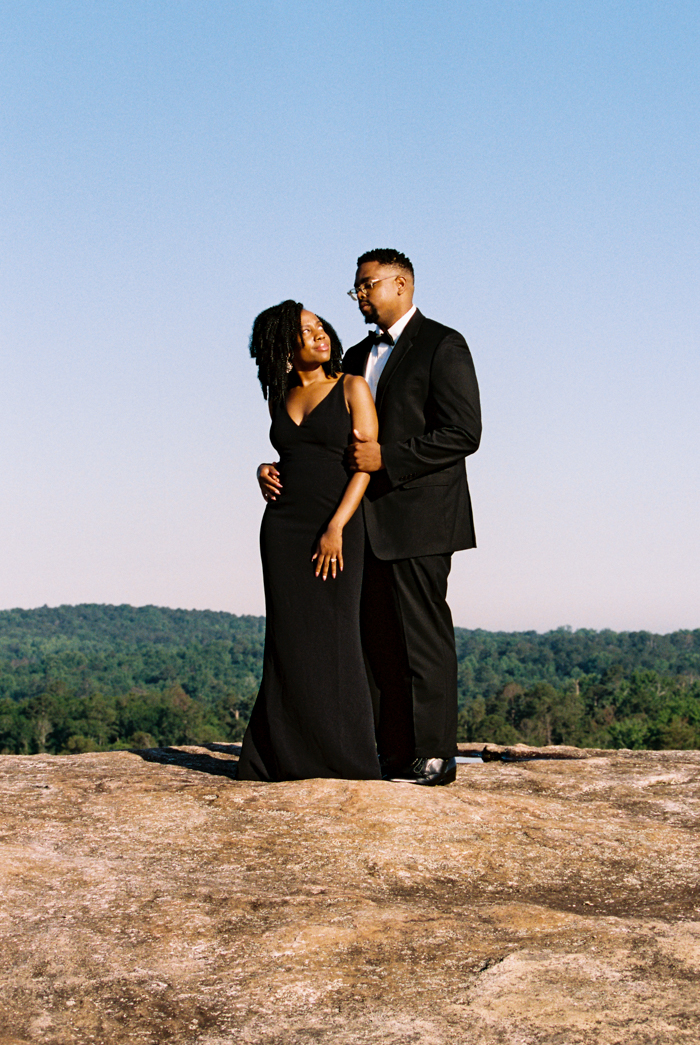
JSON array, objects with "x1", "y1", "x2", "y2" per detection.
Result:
[{"x1": 456, "y1": 628, "x2": 700, "y2": 749}]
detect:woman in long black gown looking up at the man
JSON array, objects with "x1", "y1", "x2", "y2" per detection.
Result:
[{"x1": 238, "y1": 301, "x2": 381, "y2": 781}]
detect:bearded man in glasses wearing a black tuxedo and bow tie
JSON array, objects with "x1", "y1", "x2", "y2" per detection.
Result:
[{"x1": 343, "y1": 250, "x2": 482, "y2": 786}]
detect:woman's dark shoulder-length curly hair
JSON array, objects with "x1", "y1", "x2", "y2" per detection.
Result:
[{"x1": 251, "y1": 299, "x2": 343, "y2": 403}]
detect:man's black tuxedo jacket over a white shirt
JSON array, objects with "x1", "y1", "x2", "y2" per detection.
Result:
[{"x1": 343, "y1": 310, "x2": 482, "y2": 559}]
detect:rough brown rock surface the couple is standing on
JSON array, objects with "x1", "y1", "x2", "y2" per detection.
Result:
[{"x1": 0, "y1": 745, "x2": 700, "y2": 1045}]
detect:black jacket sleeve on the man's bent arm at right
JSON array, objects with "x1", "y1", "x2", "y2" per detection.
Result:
[{"x1": 381, "y1": 331, "x2": 482, "y2": 486}]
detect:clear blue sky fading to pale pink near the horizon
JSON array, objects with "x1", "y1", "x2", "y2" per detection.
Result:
[{"x1": 0, "y1": 0, "x2": 700, "y2": 631}]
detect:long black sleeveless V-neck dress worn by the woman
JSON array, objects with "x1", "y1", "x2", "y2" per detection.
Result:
[{"x1": 238, "y1": 377, "x2": 381, "y2": 781}]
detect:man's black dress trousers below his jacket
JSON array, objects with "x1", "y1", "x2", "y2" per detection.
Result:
[{"x1": 360, "y1": 542, "x2": 457, "y2": 766}]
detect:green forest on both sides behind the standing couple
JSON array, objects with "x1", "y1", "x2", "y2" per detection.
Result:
[{"x1": 0, "y1": 605, "x2": 700, "y2": 754}]
